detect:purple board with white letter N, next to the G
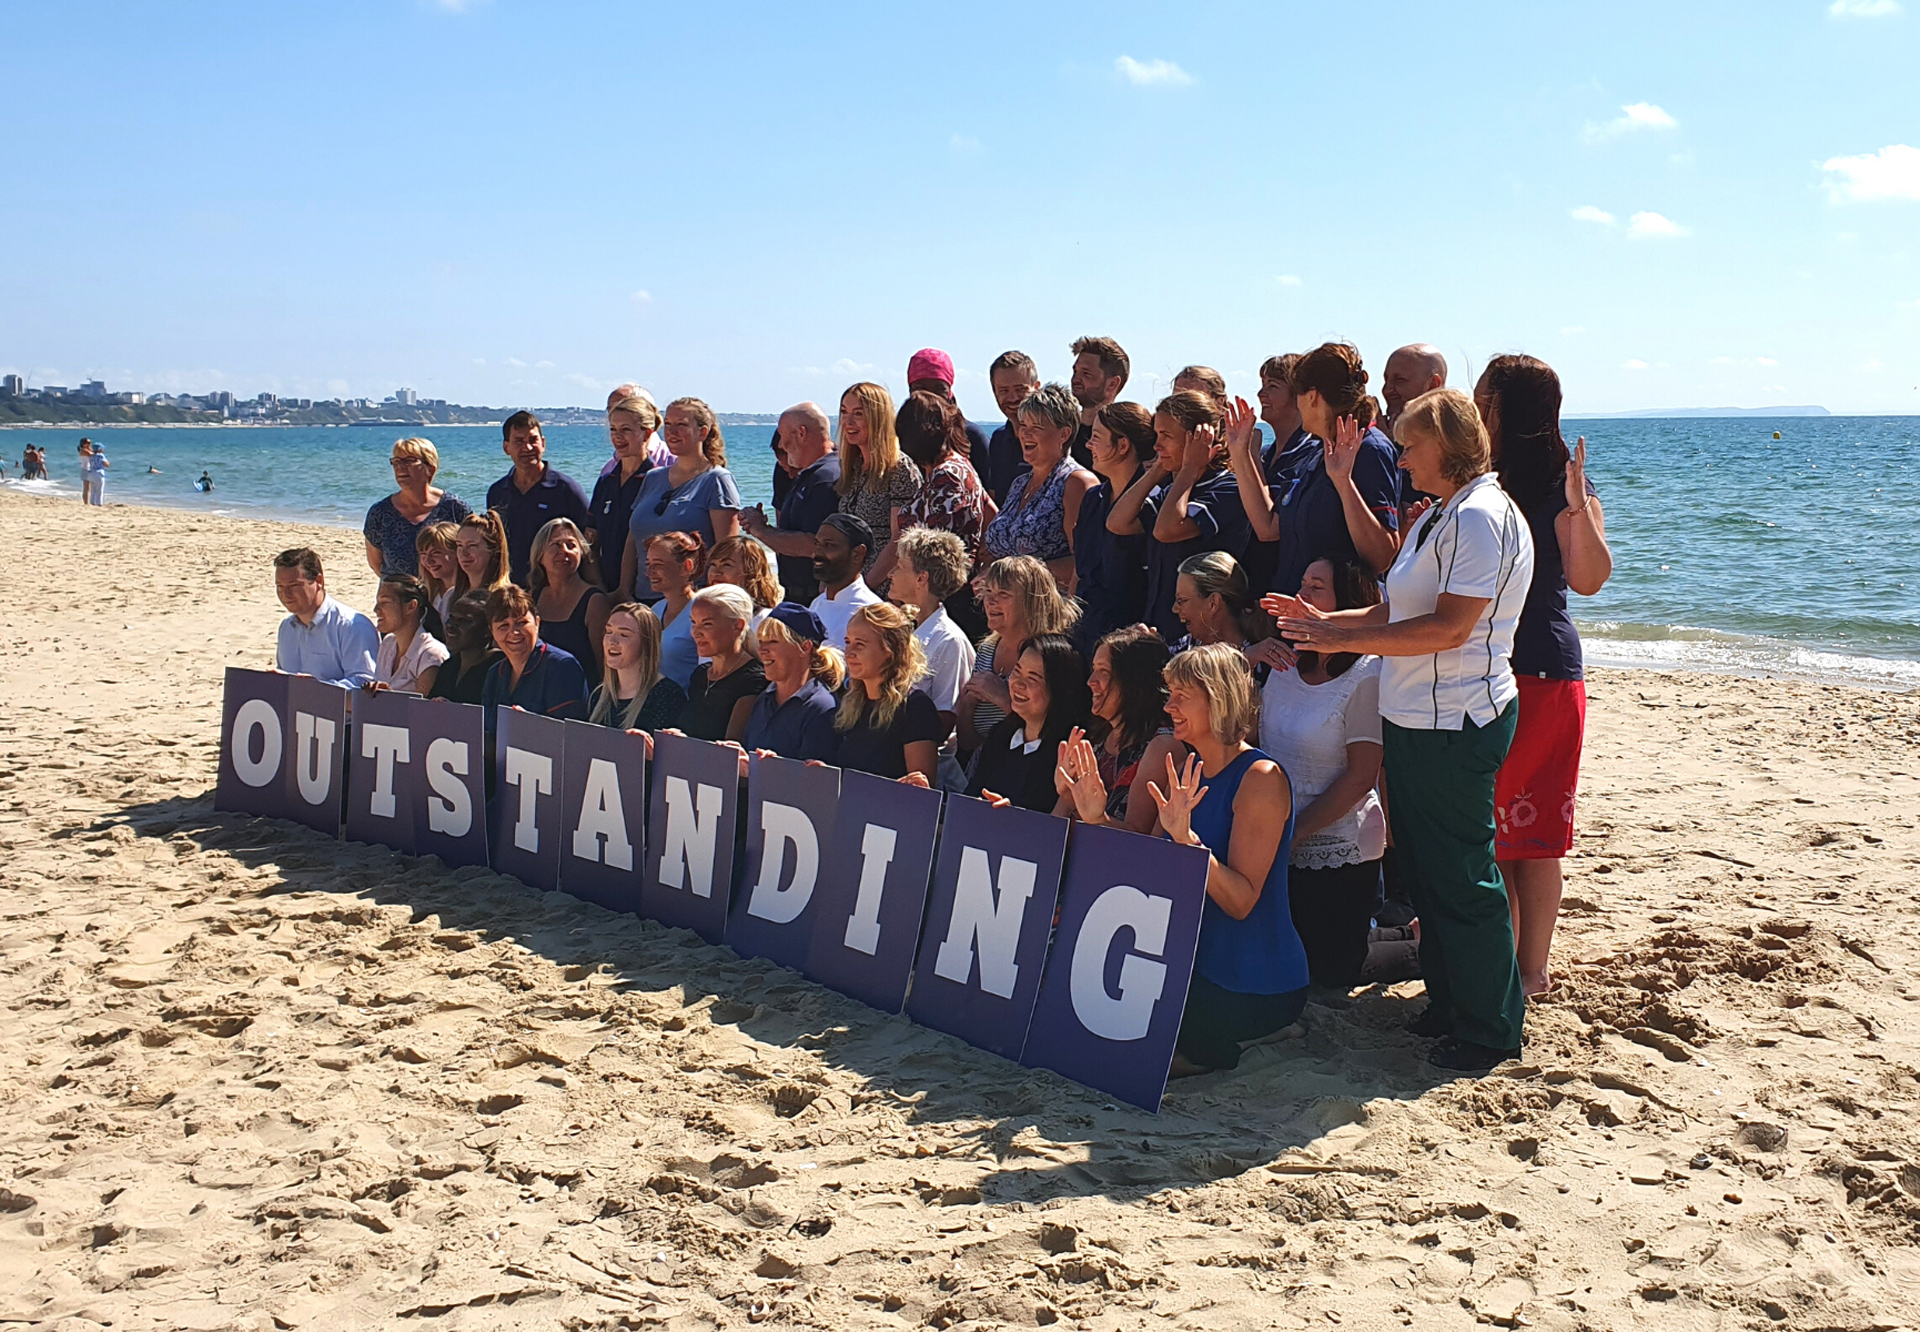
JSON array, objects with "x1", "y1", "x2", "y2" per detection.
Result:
[{"x1": 906, "y1": 797, "x2": 1068, "y2": 1059}]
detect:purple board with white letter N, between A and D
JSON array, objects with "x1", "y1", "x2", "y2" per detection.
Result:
[{"x1": 639, "y1": 735, "x2": 739, "y2": 944}]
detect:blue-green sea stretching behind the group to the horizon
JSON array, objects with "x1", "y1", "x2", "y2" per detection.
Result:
[{"x1": 0, "y1": 416, "x2": 1920, "y2": 689}]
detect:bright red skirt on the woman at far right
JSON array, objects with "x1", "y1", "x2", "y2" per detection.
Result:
[{"x1": 1494, "y1": 676, "x2": 1586, "y2": 860}]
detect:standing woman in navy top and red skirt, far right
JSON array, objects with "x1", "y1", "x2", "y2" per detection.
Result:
[{"x1": 1473, "y1": 355, "x2": 1613, "y2": 996}]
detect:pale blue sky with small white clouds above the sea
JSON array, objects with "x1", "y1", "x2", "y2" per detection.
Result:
[{"x1": 0, "y1": 0, "x2": 1920, "y2": 418}]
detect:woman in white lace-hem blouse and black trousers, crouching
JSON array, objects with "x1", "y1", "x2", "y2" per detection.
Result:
[{"x1": 1260, "y1": 559, "x2": 1386, "y2": 990}]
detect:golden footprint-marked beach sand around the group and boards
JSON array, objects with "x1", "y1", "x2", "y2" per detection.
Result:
[{"x1": 0, "y1": 493, "x2": 1920, "y2": 1332}]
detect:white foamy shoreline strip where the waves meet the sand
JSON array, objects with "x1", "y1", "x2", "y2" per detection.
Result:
[{"x1": 0, "y1": 487, "x2": 1920, "y2": 695}]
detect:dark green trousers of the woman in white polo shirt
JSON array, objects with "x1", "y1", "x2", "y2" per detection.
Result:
[{"x1": 1382, "y1": 702, "x2": 1526, "y2": 1050}]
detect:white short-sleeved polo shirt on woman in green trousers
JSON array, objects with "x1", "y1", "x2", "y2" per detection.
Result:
[{"x1": 1380, "y1": 472, "x2": 1534, "y2": 731}]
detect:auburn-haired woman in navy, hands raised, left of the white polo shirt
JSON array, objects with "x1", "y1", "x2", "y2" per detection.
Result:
[{"x1": 1227, "y1": 342, "x2": 1402, "y2": 595}]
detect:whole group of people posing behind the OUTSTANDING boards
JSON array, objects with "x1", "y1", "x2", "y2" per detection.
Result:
[{"x1": 276, "y1": 338, "x2": 1611, "y2": 1073}]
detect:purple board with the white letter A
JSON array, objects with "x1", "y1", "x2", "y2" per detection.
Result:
[{"x1": 561, "y1": 722, "x2": 647, "y2": 912}]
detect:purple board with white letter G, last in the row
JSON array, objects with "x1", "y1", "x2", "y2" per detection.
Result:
[{"x1": 1021, "y1": 825, "x2": 1208, "y2": 1113}]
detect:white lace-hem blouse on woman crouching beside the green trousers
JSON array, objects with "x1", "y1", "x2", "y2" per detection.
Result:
[{"x1": 1260, "y1": 656, "x2": 1386, "y2": 869}]
